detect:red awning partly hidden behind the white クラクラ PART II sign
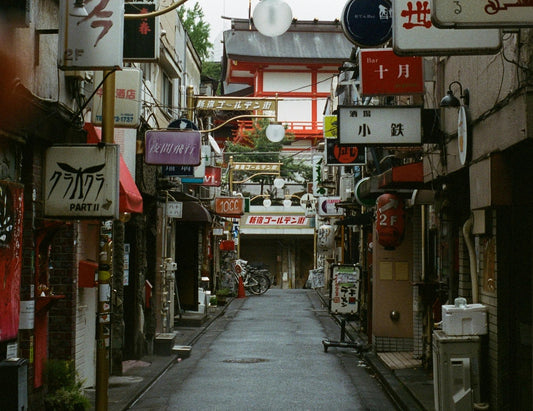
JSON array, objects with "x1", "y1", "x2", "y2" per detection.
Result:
[{"x1": 83, "y1": 123, "x2": 143, "y2": 213}]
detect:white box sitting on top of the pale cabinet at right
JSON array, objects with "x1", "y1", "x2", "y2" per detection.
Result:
[{"x1": 442, "y1": 304, "x2": 487, "y2": 335}]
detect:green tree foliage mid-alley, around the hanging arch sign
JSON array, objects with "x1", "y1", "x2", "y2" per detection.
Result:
[{"x1": 225, "y1": 119, "x2": 313, "y2": 191}]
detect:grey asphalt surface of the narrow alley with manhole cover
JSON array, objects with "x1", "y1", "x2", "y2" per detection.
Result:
[{"x1": 131, "y1": 289, "x2": 395, "y2": 411}]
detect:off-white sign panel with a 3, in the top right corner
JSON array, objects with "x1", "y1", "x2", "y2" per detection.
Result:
[{"x1": 431, "y1": 0, "x2": 533, "y2": 28}]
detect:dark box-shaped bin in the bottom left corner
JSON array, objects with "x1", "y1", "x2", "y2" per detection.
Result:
[{"x1": 0, "y1": 358, "x2": 28, "y2": 411}]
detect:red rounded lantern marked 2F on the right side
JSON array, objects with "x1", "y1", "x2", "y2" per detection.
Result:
[{"x1": 376, "y1": 193, "x2": 405, "y2": 250}]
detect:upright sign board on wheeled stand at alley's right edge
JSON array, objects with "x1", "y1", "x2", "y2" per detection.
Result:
[{"x1": 330, "y1": 264, "x2": 361, "y2": 314}]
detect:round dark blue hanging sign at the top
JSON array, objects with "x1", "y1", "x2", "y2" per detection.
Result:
[{"x1": 341, "y1": 0, "x2": 392, "y2": 47}]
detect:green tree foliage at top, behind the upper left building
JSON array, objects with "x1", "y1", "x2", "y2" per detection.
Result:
[{"x1": 178, "y1": 3, "x2": 213, "y2": 63}]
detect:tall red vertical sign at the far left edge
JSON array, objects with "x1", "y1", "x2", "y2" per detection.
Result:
[{"x1": 0, "y1": 181, "x2": 24, "y2": 341}]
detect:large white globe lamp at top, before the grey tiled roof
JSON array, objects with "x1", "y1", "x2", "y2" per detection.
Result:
[{"x1": 253, "y1": 0, "x2": 292, "y2": 37}]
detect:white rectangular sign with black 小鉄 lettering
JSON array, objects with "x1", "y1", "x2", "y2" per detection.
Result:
[{"x1": 338, "y1": 106, "x2": 422, "y2": 145}]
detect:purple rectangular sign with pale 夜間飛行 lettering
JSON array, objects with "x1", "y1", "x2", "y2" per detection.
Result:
[{"x1": 144, "y1": 130, "x2": 202, "y2": 166}]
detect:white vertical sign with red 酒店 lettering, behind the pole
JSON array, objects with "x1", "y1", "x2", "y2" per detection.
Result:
[{"x1": 91, "y1": 68, "x2": 142, "y2": 128}]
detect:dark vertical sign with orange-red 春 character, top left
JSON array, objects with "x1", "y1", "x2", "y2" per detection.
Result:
[{"x1": 124, "y1": 3, "x2": 159, "y2": 61}]
